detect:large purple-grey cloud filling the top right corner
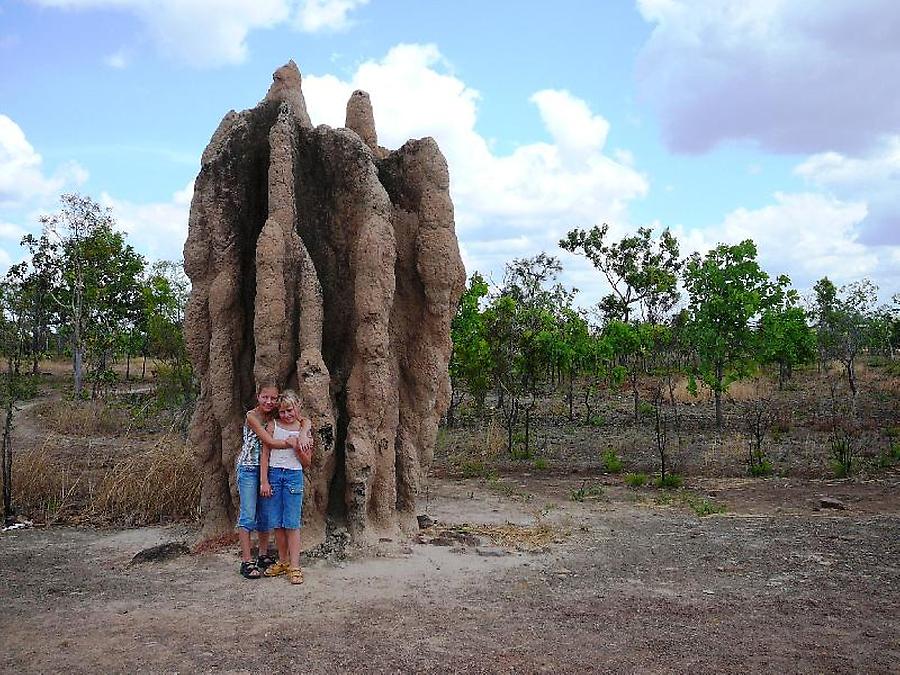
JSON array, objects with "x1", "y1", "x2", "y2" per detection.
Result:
[{"x1": 637, "y1": 0, "x2": 900, "y2": 153}]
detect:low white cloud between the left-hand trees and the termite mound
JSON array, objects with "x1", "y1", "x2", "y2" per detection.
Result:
[{"x1": 100, "y1": 181, "x2": 194, "y2": 260}]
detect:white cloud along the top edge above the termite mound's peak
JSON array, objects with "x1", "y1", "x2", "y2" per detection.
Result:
[{"x1": 31, "y1": 0, "x2": 367, "y2": 67}]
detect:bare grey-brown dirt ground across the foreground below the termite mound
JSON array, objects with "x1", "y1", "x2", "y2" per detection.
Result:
[{"x1": 0, "y1": 477, "x2": 900, "y2": 673}]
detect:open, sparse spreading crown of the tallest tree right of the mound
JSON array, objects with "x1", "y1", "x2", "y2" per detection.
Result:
[{"x1": 559, "y1": 223, "x2": 683, "y2": 323}]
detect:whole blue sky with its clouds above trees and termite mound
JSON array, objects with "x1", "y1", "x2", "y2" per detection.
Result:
[{"x1": 0, "y1": 0, "x2": 900, "y2": 304}]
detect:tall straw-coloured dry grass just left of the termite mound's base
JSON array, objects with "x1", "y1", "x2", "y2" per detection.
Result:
[{"x1": 3, "y1": 435, "x2": 201, "y2": 525}]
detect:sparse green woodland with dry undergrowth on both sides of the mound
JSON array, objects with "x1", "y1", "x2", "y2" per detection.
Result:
[{"x1": 0, "y1": 195, "x2": 900, "y2": 523}]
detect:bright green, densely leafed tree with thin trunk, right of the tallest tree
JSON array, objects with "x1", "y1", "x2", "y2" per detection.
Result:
[{"x1": 684, "y1": 239, "x2": 790, "y2": 428}]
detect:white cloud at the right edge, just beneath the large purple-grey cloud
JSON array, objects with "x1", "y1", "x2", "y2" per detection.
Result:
[{"x1": 794, "y1": 135, "x2": 900, "y2": 246}]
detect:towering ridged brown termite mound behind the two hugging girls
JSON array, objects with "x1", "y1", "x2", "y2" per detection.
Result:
[{"x1": 184, "y1": 61, "x2": 465, "y2": 548}]
